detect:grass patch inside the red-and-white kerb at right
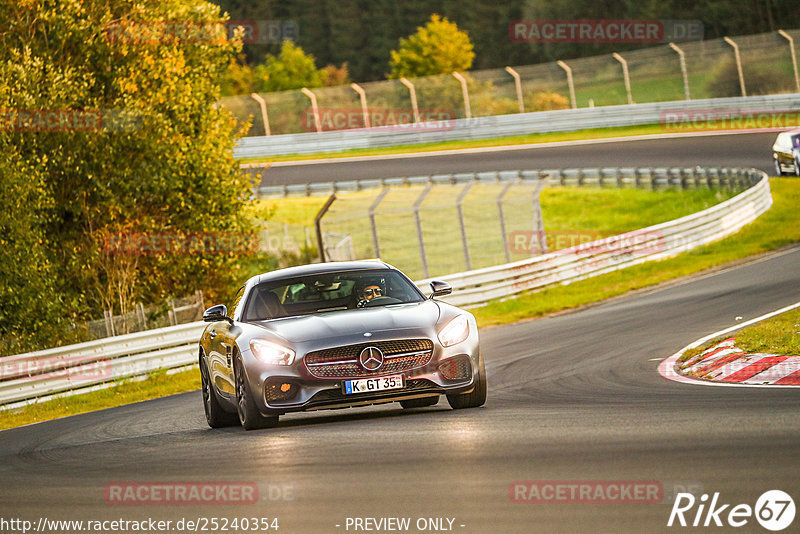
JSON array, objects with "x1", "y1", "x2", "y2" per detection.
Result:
[{"x1": 736, "y1": 308, "x2": 800, "y2": 356}]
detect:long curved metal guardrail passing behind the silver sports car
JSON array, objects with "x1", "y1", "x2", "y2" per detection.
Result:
[{"x1": 0, "y1": 169, "x2": 772, "y2": 407}]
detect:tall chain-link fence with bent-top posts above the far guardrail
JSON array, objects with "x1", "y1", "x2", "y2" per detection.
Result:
[{"x1": 221, "y1": 30, "x2": 800, "y2": 136}]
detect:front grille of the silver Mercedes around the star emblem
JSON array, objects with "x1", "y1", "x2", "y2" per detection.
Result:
[{"x1": 305, "y1": 339, "x2": 433, "y2": 378}]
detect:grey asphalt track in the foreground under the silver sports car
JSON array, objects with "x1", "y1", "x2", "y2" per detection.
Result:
[{"x1": 0, "y1": 134, "x2": 800, "y2": 534}]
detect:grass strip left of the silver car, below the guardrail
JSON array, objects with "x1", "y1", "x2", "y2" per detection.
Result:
[{"x1": 0, "y1": 369, "x2": 202, "y2": 430}]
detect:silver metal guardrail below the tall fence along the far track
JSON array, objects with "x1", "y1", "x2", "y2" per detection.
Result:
[{"x1": 233, "y1": 93, "x2": 800, "y2": 159}]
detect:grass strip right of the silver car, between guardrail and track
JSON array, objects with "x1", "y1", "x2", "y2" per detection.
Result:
[{"x1": 472, "y1": 178, "x2": 800, "y2": 326}]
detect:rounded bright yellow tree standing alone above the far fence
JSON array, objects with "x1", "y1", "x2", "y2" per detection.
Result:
[{"x1": 389, "y1": 14, "x2": 475, "y2": 79}]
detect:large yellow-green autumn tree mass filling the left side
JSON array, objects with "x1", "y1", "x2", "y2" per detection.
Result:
[{"x1": 0, "y1": 0, "x2": 251, "y2": 354}]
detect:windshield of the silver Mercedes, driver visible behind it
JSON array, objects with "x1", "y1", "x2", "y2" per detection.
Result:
[{"x1": 244, "y1": 269, "x2": 424, "y2": 321}]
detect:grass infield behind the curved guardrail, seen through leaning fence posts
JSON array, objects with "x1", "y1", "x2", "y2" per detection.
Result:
[{"x1": 261, "y1": 184, "x2": 732, "y2": 279}]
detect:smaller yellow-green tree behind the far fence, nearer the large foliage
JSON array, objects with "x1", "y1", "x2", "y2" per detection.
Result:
[{"x1": 255, "y1": 39, "x2": 324, "y2": 92}]
